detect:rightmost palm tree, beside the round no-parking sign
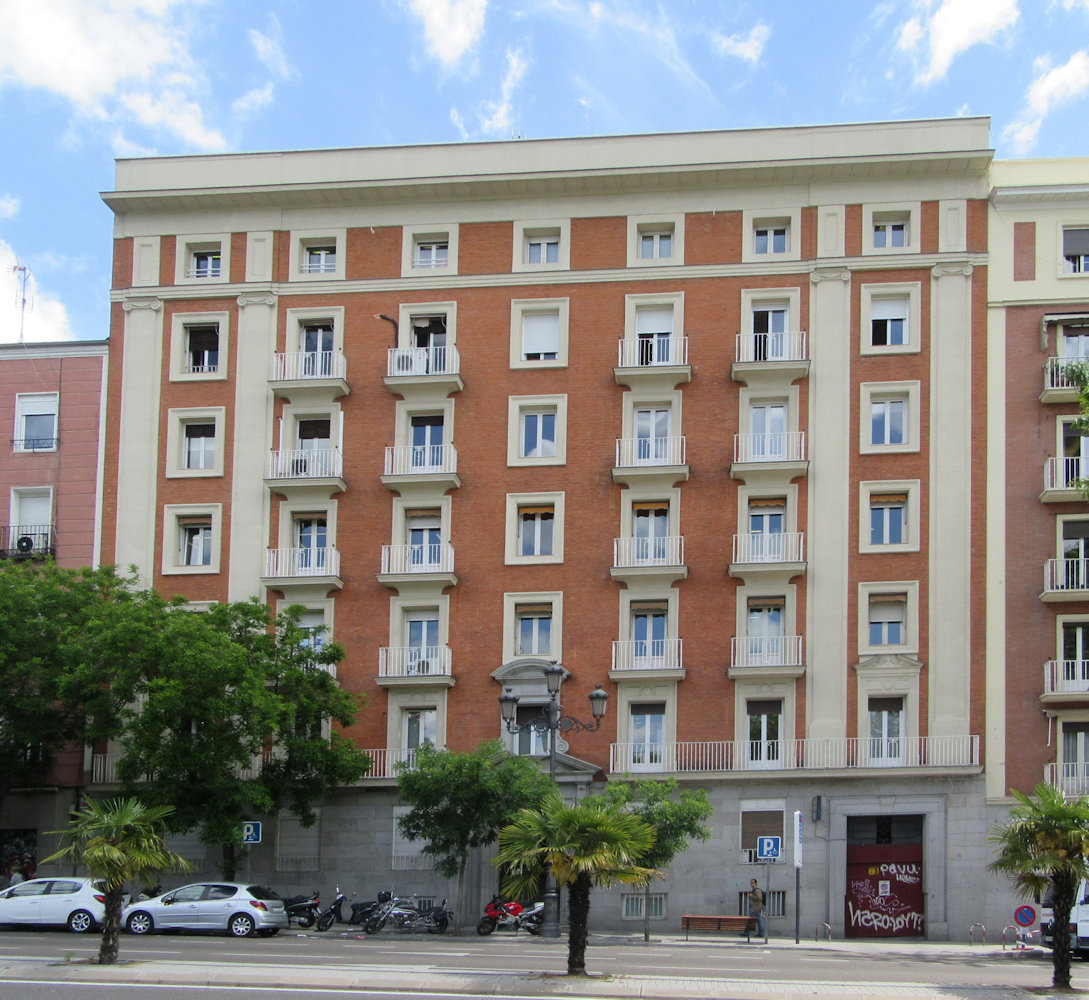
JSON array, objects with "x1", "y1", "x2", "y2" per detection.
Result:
[{"x1": 988, "y1": 783, "x2": 1089, "y2": 989}]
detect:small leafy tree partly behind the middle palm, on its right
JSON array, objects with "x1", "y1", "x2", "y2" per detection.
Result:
[{"x1": 604, "y1": 778, "x2": 713, "y2": 941}]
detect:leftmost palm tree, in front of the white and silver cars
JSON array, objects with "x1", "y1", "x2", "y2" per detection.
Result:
[{"x1": 46, "y1": 797, "x2": 189, "y2": 965}]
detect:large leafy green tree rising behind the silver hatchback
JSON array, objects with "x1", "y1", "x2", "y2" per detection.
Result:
[{"x1": 118, "y1": 600, "x2": 370, "y2": 879}]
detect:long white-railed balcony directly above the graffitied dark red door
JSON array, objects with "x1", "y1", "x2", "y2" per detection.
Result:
[{"x1": 609, "y1": 736, "x2": 984, "y2": 786}]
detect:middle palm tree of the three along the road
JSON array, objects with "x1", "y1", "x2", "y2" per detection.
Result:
[{"x1": 495, "y1": 791, "x2": 661, "y2": 975}]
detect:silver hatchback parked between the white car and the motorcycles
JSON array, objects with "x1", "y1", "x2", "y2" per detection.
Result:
[{"x1": 122, "y1": 882, "x2": 287, "y2": 938}]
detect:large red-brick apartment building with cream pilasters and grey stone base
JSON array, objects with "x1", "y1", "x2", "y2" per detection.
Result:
[{"x1": 89, "y1": 119, "x2": 997, "y2": 938}]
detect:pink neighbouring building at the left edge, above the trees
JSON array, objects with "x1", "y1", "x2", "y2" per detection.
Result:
[{"x1": 0, "y1": 340, "x2": 109, "y2": 566}]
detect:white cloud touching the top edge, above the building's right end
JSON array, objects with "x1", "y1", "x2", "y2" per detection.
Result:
[{"x1": 896, "y1": 0, "x2": 1020, "y2": 84}]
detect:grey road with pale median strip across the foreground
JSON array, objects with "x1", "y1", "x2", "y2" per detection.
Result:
[{"x1": 0, "y1": 929, "x2": 1075, "y2": 1000}]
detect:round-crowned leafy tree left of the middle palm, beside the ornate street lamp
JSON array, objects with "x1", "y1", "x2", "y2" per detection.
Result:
[{"x1": 397, "y1": 740, "x2": 553, "y2": 932}]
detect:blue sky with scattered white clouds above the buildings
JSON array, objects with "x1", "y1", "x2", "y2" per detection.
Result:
[{"x1": 0, "y1": 0, "x2": 1089, "y2": 342}]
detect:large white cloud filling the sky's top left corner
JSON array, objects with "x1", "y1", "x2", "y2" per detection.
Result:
[{"x1": 0, "y1": 0, "x2": 224, "y2": 149}]
